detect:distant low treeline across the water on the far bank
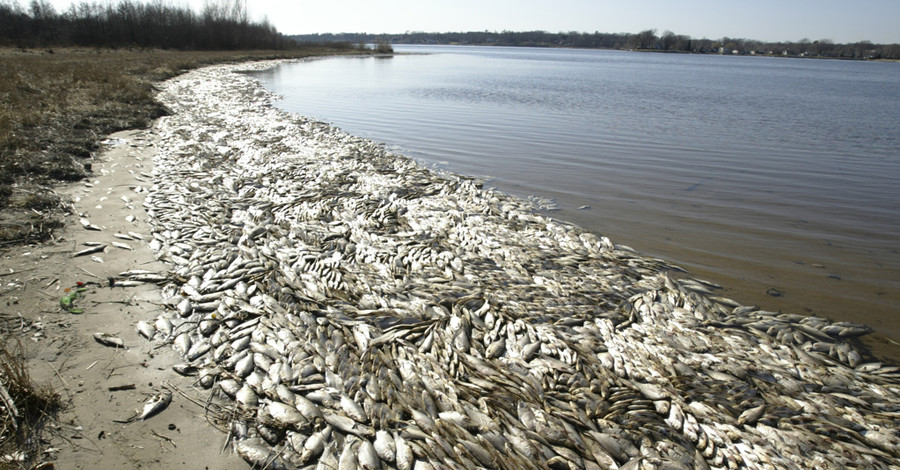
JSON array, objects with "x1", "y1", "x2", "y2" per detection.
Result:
[{"x1": 289, "y1": 29, "x2": 900, "y2": 60}]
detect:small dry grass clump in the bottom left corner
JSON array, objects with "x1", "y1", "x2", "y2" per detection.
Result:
[{"x1": 0, "y1": 339, "x2": 62, "y2": 470}]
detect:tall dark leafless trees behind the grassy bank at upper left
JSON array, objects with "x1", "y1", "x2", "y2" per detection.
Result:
[{"x1": 0, "y1": 0, "x2": 296, "y2": 50}]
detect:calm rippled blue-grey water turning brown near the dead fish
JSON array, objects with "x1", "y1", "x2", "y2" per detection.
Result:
[{"x1": 258, "y1": 46, "x2": 900, "y2": 360}]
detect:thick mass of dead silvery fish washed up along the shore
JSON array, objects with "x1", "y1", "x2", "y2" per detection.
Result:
[{"x1": 119, "y1": 63, "x2": 900, "y2": 470}]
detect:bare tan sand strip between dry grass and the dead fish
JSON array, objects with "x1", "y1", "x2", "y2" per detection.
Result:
[{"x1": 2, "y1": 127, "x2": 246, "y2": 469}]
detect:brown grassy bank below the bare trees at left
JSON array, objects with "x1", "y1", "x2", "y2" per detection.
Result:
[{"x1": 0, "y1": 46, "x2": 360, "y2": 246}]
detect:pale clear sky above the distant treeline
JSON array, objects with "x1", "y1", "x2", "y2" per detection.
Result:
[{"x1": 38, "y1": 0, "x2": 900, "y2": 44}]
